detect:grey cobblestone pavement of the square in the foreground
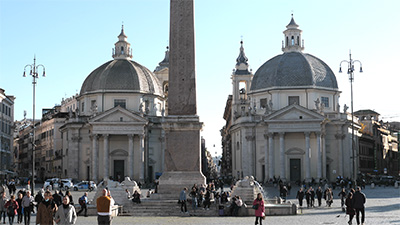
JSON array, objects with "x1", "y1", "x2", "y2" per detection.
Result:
[{"x1": 3, "y1": 186, "x2": 400, "y2": 225}]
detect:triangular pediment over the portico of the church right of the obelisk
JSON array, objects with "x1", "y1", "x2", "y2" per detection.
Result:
[{"x1": 266, "y1": 104, "x2": 325, "y2": 121}]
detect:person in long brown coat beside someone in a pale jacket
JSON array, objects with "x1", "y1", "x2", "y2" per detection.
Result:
[{"x1": 36, "y1": 191, "x2": 58, "y2": 225}]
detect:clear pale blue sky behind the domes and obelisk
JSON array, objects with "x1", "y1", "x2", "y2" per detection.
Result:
[{"x1": 0, "y1": 0, "x2": 400, "y2": 154}]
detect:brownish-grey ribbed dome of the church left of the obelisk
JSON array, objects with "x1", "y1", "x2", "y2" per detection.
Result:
[{"x1": 80, "y1": 59, "x2": 162, "y2": 96}]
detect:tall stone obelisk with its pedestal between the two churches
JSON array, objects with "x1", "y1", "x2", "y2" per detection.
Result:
[{"x1": 159, "y1": 0, "x2": 205, "y2": 199}]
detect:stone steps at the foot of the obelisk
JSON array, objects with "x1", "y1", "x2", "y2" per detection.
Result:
[{"x1": 122, "y1": 199, "x2": 218, "y2": 216}]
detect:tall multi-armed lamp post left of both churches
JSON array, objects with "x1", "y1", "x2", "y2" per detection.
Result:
[{"x1": 23, "y1": 56, "x2": 46, "y2": 193}]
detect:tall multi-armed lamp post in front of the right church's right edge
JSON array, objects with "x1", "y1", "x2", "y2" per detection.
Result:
[{"x1": 339, "y1": 51, "x2": 363, "y2": 185}]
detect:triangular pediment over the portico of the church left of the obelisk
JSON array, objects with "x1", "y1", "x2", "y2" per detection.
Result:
[{"x1": 90, "y1": 106, "x2": 147, "y2": 123}]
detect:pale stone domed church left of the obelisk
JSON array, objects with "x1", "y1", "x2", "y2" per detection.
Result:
[{"x1": 60, "y1": 26, "x2": 169, "y2": 182}]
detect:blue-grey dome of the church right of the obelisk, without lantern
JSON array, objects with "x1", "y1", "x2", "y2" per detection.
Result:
[{"x1": 250, "y1": 52, "x2": 338, "y2": 91}]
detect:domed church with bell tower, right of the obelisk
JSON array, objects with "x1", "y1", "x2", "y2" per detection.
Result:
[{"x1": 222, "y1": 15, "x2": 352, "y2": 182}]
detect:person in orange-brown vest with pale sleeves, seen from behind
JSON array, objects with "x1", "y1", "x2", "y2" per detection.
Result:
[{"x1": 96, "y1": 189, "x2": 114, "y2": 225}]
